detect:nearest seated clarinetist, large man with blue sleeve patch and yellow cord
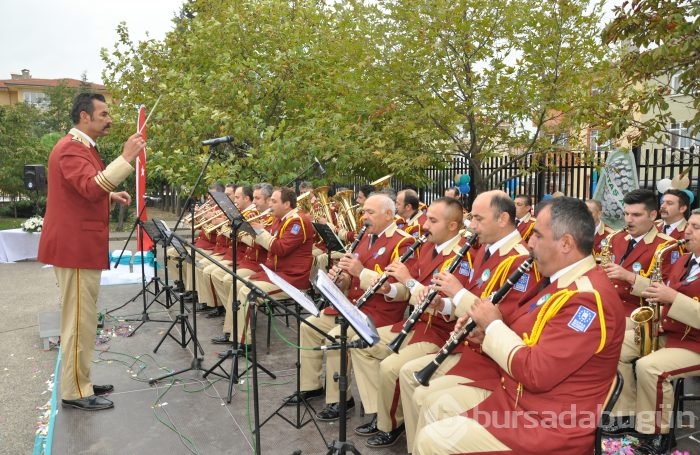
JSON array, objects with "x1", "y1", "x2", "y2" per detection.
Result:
[{"x1": 413, "y1": 197, "x2": 625, "y2": 455}]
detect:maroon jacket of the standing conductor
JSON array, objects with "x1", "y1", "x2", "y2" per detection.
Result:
[{"x1": 38, "y1": 129, "x2": 133, "y2": 269}]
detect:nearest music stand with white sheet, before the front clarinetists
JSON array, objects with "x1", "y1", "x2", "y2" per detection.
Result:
[{"x1": 315, "y1": 270, "x2": 379, "y2": 455}]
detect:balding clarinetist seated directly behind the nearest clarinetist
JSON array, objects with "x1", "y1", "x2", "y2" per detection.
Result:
[{"x1": 400, "y1": 191, "x2": 539, "y2": 450}]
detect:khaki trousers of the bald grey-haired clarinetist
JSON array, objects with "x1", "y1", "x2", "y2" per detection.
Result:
[{"x1": 299, "y1": 313, "x2": 355, "y2": 403}]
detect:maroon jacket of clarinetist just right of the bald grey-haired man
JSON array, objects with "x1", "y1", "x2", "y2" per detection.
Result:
[{"x1": 391, "y1": 238, "x2": 471, "y2": 346}]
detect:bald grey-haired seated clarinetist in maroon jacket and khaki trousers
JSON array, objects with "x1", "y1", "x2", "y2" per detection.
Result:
[{"x1": 285, "y1": 194, "x2": 414, "y2": 421}]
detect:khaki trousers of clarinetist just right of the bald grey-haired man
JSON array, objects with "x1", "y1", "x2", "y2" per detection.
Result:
[{"x1": 351, "y1": 326, "x2": 438, "y2": 431}]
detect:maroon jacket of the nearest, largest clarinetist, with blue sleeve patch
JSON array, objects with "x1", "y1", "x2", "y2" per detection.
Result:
[{"x1": 464, "y1": 256, "x2": 625, "y2": 455}]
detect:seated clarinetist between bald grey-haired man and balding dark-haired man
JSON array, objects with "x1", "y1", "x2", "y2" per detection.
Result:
[{"x1": 350, "y1": 198, "x2": 473, "y2": 447}]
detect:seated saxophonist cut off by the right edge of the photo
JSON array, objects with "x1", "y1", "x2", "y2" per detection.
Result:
[{"x1": 613, "y1": 209, "x2": 700, "y2": 454}]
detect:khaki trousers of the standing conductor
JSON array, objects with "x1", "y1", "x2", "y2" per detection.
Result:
[{"x1": 54, "y1": 267, "x2": 102, "y2": 400}]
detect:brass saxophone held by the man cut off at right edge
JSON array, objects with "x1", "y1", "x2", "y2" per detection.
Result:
[{"x1": 630, "y1": 240, "x2": 685, "y2": 357}]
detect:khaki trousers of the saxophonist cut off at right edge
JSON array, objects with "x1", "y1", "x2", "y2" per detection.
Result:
[{"x1": 612, "y1": 330, "x2": 700, "y2": 434}]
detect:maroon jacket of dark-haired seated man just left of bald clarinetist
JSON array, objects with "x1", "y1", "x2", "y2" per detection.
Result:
[{"x1": 250, "y1": 212, "x2": 314, "y2": 289}]
